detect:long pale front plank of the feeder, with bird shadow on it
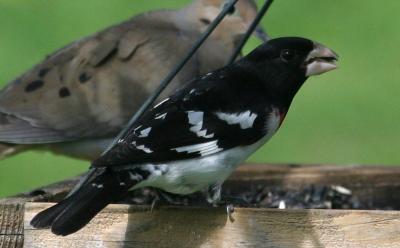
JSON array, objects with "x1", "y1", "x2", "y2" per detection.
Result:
[{"x1": 24, "y1": 203, "x2": 400, "y2": 248}]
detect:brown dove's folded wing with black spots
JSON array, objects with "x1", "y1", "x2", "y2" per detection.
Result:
[{"x1": 0, "y1": 12, "x2": 198, "y2": 143}]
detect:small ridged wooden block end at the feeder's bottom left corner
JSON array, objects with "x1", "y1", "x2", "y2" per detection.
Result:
[{"x1": 0, "y1": 204, "x2": 24, "y2": 248}]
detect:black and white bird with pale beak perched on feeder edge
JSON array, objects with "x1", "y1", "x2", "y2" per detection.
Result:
[{"x1": 31, "y1": 37, "x2": 338, "y2": 235}]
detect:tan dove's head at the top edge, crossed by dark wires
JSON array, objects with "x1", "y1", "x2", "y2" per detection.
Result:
[{"x1": 187, "y1": 0, "x2": 268, "y2": 42}]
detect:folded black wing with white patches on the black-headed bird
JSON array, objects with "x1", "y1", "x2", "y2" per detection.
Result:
[{"x1": 92, "y1": 69, "x2": 267, "y2": 167}]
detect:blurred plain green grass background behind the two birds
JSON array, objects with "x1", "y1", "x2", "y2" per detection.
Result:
[{"x1": 0, "y1": 0, "x2": 400, "y2": 197}]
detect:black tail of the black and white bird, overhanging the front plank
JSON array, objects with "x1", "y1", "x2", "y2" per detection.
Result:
[{"x1": 31, "y1": 167, "x2": 148, "y2": 236}]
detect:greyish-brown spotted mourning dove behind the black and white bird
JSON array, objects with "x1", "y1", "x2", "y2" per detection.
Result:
[{"x1": 0, "y1": 0, "x2": 264, "y2": 160}]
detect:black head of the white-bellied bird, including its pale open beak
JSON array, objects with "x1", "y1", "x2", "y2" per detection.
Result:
[{"x1": 238, "y1": 37, "x2": 338, "y2": 101}]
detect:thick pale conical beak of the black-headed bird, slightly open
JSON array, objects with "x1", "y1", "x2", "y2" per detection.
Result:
[{"x1": 305, "y1": 43, "x2": 339, "y2": 77}]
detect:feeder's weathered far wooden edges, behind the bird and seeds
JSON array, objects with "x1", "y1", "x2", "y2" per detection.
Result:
[{"x1": 4, "y1": 164, "x2": 400, "y2": 204}]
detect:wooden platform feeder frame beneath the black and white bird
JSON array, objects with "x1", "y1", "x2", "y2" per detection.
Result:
[{"x1": 0, "y1": 165, "x2": 400, "y2": 248}]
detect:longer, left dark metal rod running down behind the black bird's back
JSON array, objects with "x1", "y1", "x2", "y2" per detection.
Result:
[{"x1": 102, "y1": 0, "x2": 238, "y2": 155}]
